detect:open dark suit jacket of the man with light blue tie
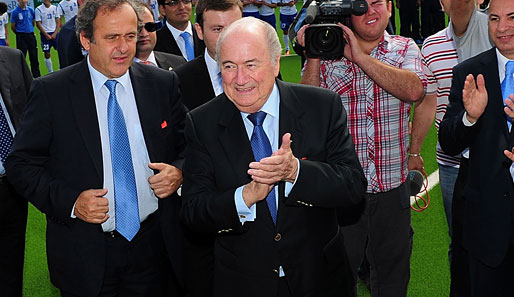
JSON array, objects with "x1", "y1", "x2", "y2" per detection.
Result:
[{"x1": 6, "y1": 60, "x2": 185, "y2": 296}]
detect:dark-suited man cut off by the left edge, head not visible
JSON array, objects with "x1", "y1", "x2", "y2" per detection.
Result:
[{"x1": 0, "y1": 46, "x2": 32, "y2": 297}]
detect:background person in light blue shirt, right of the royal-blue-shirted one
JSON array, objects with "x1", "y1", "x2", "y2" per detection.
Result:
[{"x1": 36, "y1": 0, "x2": 61, "y2": 73}]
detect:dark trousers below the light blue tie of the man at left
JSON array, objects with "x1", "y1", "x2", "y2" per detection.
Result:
[{"x1": 61, "y1": 215, "x2": 169, "y2": 297}]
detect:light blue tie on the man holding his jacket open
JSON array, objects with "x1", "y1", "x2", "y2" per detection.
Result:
[{"x1": 105, "y1": 80, "x2": 139, "y2": 241}]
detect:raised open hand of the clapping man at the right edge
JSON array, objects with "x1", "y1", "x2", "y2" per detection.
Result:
[{"x1": 462, "y1": 74, "x2": 488, "y2": 123}]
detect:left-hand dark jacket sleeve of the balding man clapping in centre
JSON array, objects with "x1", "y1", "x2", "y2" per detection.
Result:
[{"x1": 182, "y1": 113, "x2": 243, "y2": 232}]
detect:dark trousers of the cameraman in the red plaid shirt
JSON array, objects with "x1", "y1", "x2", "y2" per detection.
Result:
[{"x1": 343, "y1": 183, "x2": 412, "y2": 297}]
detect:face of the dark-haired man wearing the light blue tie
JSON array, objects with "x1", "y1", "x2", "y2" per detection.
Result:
[{"x1": 80, "y1": 4, "x2": 137, "y2": 78}]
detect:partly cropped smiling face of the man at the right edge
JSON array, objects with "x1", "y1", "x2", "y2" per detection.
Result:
[{"x1": 489, "y1": 0, "x2": 514, "y2": 60}]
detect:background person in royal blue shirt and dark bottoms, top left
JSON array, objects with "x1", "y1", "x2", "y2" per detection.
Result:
[{"x1": 11, "y1": 0, "x2": 41, "y2": 78}]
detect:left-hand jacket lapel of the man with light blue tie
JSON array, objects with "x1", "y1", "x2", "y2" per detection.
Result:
[{"x1": 69, "y1": 59, "x2": 103, "y2": 181}]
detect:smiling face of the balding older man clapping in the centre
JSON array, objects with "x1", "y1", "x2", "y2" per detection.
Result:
[{"x1": 219, "y1": 27, "x2": 280, "y2": 113}]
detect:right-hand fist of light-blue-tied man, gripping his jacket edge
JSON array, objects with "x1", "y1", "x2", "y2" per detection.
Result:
[{"x1": 148, "y1": 163, "x2": 182, "y2": 198}]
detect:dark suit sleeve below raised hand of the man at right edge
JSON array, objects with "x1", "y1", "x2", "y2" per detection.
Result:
[{"x1": 439, "y1": 67, "x2": 480, "y2": 156}]
